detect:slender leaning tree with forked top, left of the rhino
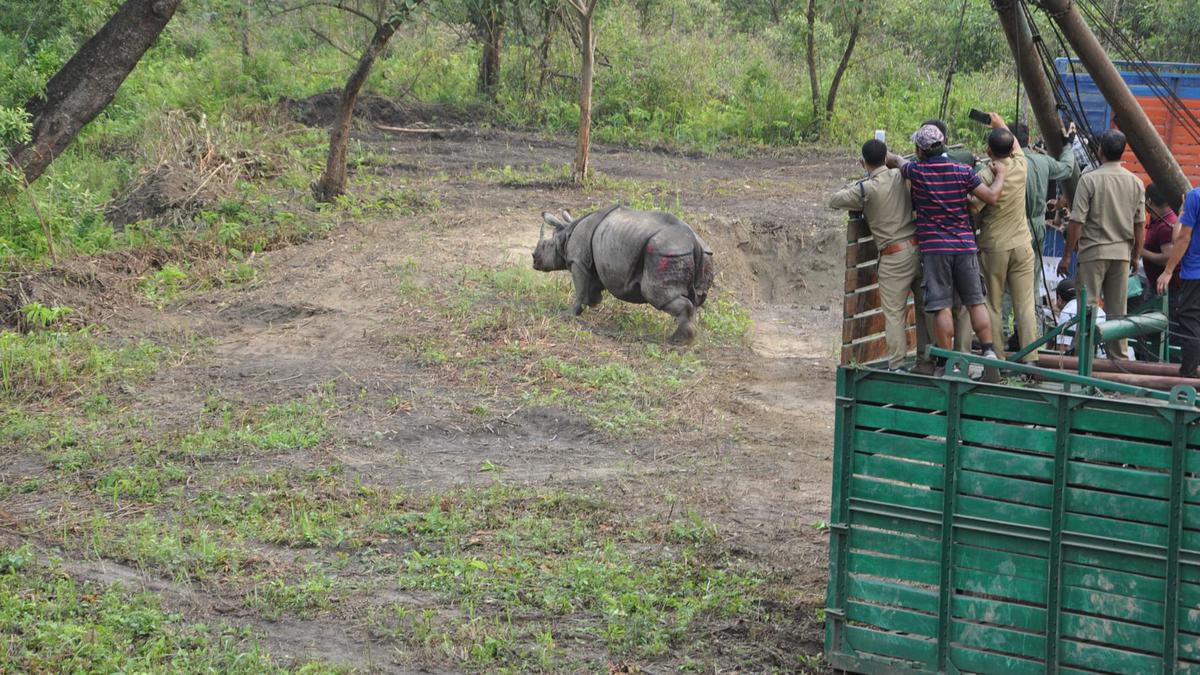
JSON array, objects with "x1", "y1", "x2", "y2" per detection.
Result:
[{"x1": 312, "y1": 0, "x2": 422, "y2": 202}]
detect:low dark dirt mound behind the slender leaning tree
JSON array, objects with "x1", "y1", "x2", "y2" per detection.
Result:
[{"x1": 282, "y1": 89, "x2": 485, "y2": 127}]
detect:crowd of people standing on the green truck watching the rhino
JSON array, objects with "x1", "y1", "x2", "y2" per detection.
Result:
[{"x1": 829, "y1": 113, "x2": 1200, "y2": 382}]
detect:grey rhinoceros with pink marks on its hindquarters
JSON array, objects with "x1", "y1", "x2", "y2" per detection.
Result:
[{"x1": 533, "y1": 204, "x2": 714, "y2": 344}]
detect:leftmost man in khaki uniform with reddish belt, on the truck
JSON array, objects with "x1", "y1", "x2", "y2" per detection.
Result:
[{"x1": 829, "y1": 139, "x2": 934, "y2": 374}]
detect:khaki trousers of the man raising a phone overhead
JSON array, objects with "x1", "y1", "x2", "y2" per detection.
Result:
[{"x1": 979, "y1": 246, "x2": 1042, "y2": 363}]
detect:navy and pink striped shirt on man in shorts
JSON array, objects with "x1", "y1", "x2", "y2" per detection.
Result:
[{"x1": 902, "y1": 155, "x2": 982, "y2": 256}]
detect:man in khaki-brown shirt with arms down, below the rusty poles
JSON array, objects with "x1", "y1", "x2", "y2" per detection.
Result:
[{"x1": 1058, "y1": 129, "x2": 1146, "y2": 359}]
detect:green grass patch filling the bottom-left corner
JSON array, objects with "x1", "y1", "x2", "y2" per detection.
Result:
[{"x1": 0, "y1": 549, "x2": 283, "y2": 675}]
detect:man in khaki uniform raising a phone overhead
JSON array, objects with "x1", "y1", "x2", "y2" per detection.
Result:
[{"x1": 971, "y1": 113, "x2": 1040, "y2": 363}]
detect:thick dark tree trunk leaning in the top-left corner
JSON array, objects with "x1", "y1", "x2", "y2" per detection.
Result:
[{"x1": 10, "y1": 0, "x2": 181, "y2": 183}]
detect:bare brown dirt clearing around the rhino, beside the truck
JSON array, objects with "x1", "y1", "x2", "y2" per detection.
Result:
[{"x1": 8, "y1": 121, "x2": 848, "y2": 670}]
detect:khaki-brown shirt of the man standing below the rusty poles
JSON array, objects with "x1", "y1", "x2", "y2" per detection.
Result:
[{"x1": 1070, "y1": 162, "x2": 1146, "y2": 262}]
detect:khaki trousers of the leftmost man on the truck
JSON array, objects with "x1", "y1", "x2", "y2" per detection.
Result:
[{"x1": 880, "y1": 246, "x2": 929, "y2": 368}]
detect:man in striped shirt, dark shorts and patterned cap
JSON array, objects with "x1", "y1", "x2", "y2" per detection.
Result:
[{"x1": 888, "y1": 125, "x2": 1006, "y2": 372}]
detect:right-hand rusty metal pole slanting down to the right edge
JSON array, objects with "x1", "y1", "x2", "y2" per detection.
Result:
[{"x1": 1040, "y1": 0, "x2": 1192, "y2": 201}]
